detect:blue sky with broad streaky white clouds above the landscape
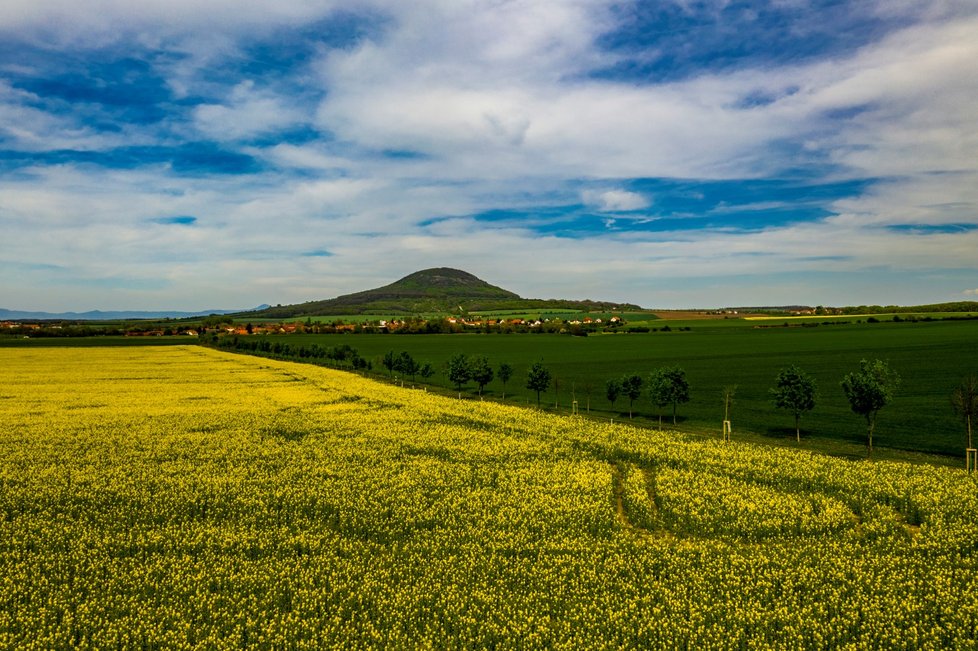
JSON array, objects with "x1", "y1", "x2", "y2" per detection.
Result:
[{"x1": 0, "y1": 0, "x2": 978, "y2": 311}]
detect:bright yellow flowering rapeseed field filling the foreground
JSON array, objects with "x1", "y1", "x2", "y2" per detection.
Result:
[{"x1": 0, "y1": 346, "x2": 978, "y2": 649}]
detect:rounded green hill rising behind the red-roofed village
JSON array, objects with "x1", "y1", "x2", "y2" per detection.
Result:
[{"x1": 248, "y1": 267, "x2": 641, "y2": 318}]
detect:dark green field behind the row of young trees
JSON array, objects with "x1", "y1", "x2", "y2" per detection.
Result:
[{"x1": 252, "y1": 319, "x2": 978, "y2": 464}]
